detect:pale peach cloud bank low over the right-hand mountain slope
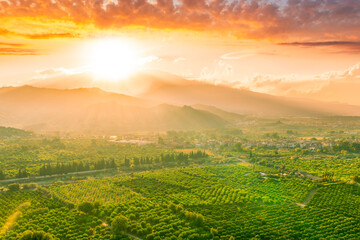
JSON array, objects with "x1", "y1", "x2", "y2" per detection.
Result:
[{"x1": 242, "y1": 63, "x2": 360, "y2": 105}]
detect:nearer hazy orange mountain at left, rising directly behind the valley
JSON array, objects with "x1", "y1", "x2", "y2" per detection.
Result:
[{"x1": 0, "y1": 86, "x2": 228, "y2": 134}]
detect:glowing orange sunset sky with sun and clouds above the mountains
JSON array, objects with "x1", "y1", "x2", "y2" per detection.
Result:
[{"x1": 0, "y1": 0, "x2": 360, "y2": 105}]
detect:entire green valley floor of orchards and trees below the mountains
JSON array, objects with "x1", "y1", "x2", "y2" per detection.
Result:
[{"x1": 0, "y1": 117, "x2": 360, "y2": 240}]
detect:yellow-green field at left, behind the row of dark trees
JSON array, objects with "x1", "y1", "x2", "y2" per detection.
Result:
[{"x1": 0, "y1": 138, "x2": 166, "y2": 177}]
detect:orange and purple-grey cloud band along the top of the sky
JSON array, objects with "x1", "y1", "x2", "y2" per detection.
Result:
[{"x1": 0, "y1": 0, "x2": 360, "y2": 41}]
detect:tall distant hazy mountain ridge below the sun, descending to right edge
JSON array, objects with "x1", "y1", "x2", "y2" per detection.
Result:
[{"x1": 28, "y1": 71, "x2": 360, "y2": 117}]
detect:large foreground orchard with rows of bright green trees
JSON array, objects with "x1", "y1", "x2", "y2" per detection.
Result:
[{"x1": 0, "y1": 164, "x2": 360, "y2": 239}]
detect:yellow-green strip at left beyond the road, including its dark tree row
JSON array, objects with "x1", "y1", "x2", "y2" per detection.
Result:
[{"x1": 0, "y1": 138, "x2": 214, "y2": 180}]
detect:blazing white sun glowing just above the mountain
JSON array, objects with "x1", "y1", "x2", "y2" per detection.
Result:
[{"x1": 88, "y1": 39, "x2": 141, "y2": 82}]
